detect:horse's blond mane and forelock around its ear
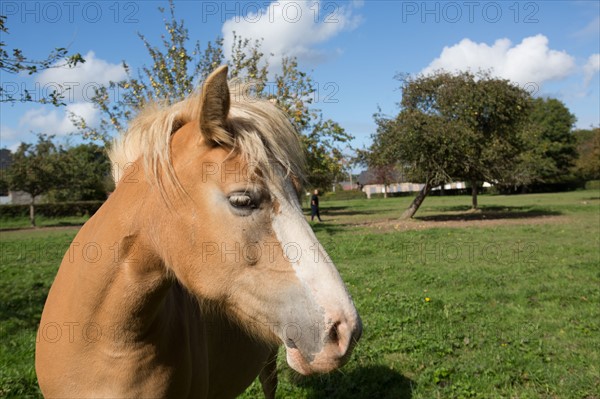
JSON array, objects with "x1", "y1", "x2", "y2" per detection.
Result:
[{"x1": 109, "y1": 84, "x2": 305, "y2": 193}]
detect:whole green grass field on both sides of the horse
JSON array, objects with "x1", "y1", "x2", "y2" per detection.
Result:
[{"x1": 0, "y1": 191, "x2": 600, "y2": 399}]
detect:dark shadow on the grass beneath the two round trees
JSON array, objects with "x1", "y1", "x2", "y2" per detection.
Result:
[{"x1": 415, "y1": 206, "x2": 562, "y2": 222}]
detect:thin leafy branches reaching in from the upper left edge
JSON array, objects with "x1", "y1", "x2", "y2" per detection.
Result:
[{"x1": 0, "y1": 15, "x2": 85, "y2": 106}]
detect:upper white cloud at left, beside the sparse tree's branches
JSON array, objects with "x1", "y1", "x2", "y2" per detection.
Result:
[{"x1": 36, "y1": 51, "x2": 127, "y2": 103}]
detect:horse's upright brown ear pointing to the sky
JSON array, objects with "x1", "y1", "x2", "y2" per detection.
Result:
[{"x1": 200, "y1": 65, "x2": 232, "y2": 144}]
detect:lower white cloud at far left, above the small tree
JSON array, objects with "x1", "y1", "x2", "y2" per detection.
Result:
[{"x1": 19, "y1": 102, "x2": 99, "y2": 136}]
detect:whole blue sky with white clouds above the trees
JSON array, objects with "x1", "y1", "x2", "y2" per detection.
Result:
[{"x1": 0, "y1": 0, "x2": 600, "y2": 153}]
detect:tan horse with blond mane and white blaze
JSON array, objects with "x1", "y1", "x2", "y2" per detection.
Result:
[{"x1": 35, "y1": 66, "x2": 362, "y2": 398}]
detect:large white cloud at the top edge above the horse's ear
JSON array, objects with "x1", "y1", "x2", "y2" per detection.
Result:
[{"x1": 222, "y1": 0, "x2": 362, "y2": 65}]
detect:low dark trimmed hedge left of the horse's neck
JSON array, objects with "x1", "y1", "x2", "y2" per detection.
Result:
[{"x1": 0, "y1": 201, "x2": 104, "y2": 218}]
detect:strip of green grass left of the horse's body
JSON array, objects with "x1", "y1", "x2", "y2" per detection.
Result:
[{"x1": 0, "y1": 229, "x2": 77, "y2": 398}]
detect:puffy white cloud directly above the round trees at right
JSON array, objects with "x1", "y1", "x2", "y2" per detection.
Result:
[{"x1": 421, "y1": 35, "x2": 575, "y2": 86}]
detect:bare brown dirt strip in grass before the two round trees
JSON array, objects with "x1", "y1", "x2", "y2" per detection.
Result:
[{"x1": 352, "y1": 215, "x2": 570, "y2": 231}]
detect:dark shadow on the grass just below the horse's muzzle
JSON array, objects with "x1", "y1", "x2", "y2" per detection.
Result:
[{"x1": 292, "y1": 365, "x2": 415, "y2": 399}]
